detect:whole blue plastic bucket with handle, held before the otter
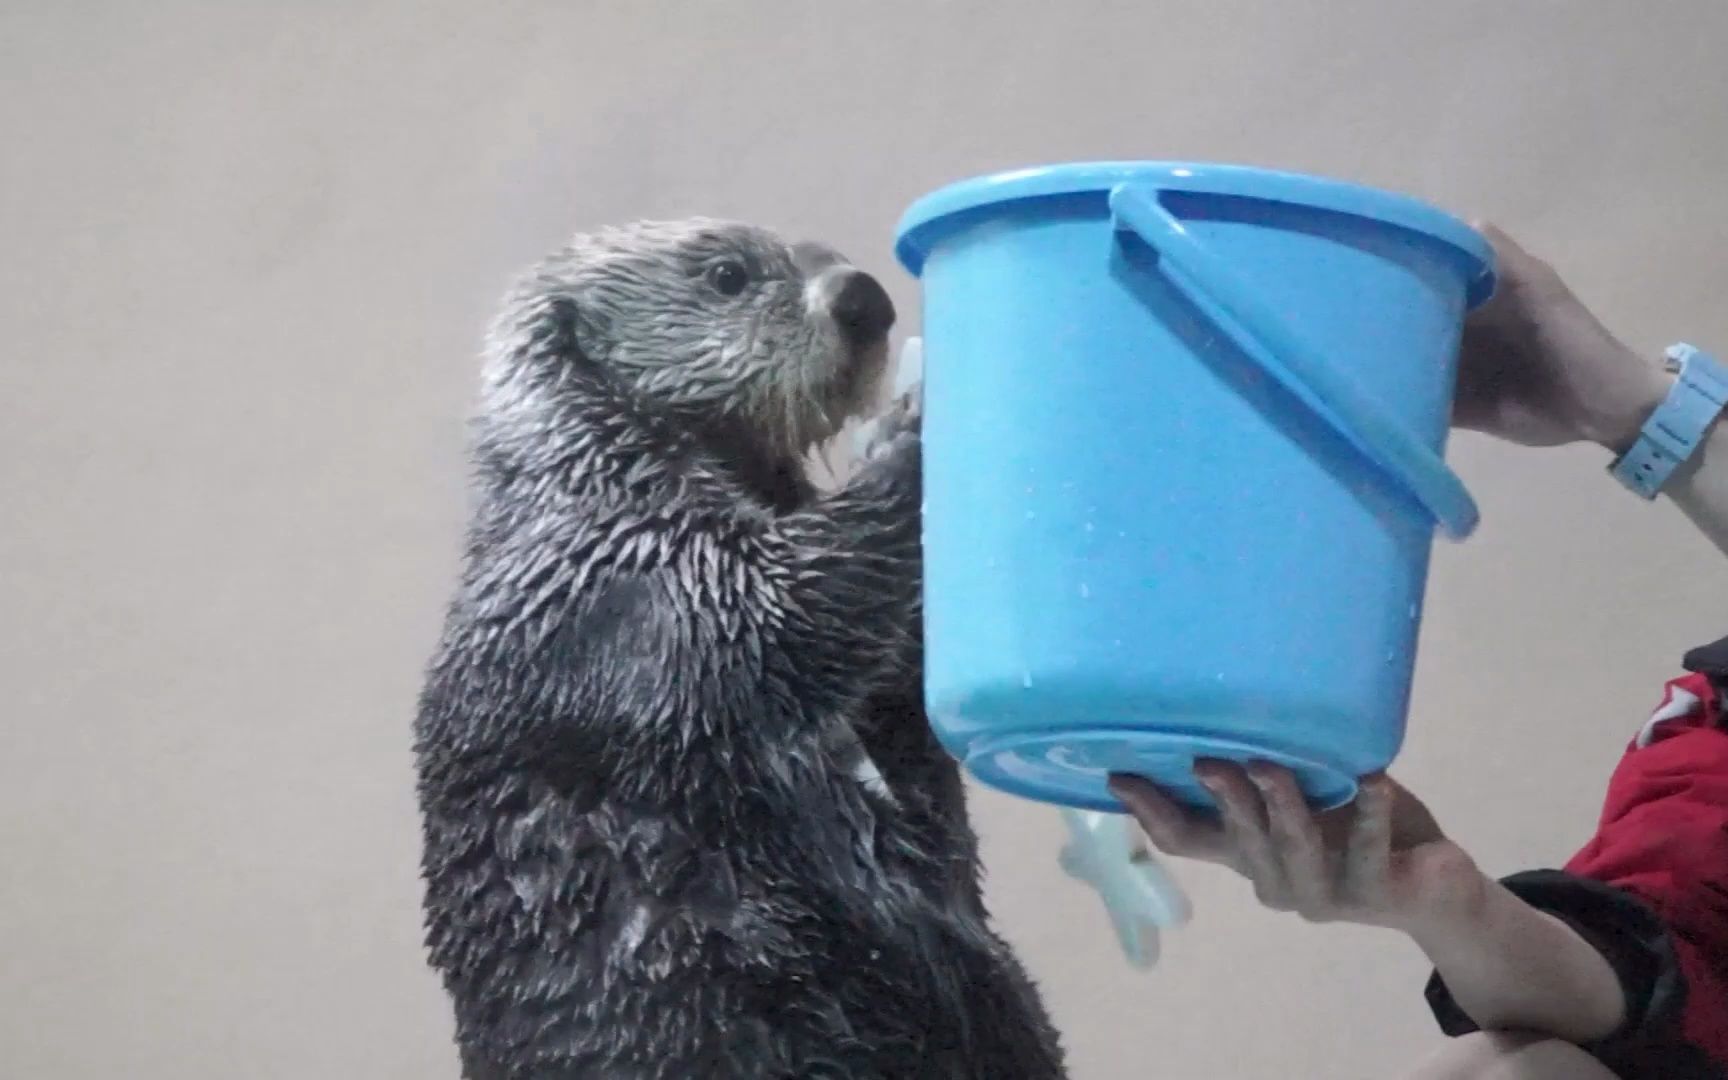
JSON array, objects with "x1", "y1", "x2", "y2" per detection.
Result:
[{"x1": 897, "y1": 162, "x2": 1493, "y2": 810}]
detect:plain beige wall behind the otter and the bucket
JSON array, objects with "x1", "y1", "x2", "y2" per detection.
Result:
[{"x1": 0, "y1": 0, "x2": 1728, "y2": 1080}]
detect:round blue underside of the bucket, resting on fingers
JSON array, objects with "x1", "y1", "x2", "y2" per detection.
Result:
[{"x1": 966, "y1": 729, "x2": 1356, "y2": 814}]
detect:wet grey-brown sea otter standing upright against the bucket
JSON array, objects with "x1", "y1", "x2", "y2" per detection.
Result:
[{"x1": 415, "y1": 221, "x2": 1063, "y2": 1080}]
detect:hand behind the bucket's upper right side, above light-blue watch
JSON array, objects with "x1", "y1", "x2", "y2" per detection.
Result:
[{"x1": 1453, "y1": 225, "x2": 1668, "y2": 453}]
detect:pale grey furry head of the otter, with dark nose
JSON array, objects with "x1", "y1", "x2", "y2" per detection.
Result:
[{"x1": 487, "y1": 219, "x2": 895, "y2": 487}]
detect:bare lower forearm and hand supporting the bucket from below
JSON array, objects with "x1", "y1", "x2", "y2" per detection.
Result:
[{"x1": 1111, "y1": 762, "x2": 1626, "y2": 1042}]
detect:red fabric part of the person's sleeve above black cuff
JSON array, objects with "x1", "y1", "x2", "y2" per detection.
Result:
[{"x1": 1566, "y1": 674, "x2": 1728, "y2": 1063}]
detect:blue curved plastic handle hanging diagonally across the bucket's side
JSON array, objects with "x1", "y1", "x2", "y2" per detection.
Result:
[{"x1": 1109, "y1": 183, "x2": 1479, "y2": 539}]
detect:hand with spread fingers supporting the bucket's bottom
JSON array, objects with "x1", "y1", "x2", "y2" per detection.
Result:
[{"x1": 1111, "y1": 762, "x2": 1491, "y2": 935}]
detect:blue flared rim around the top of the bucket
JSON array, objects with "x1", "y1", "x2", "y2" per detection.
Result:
[{"x1": 893, "y1": 161, "x2": 1495, "y2": 308}]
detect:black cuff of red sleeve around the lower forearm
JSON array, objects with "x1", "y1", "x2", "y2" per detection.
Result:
[{"x1": 1427, "y1": 869, "x2": 1723, "y2": 1080}]
